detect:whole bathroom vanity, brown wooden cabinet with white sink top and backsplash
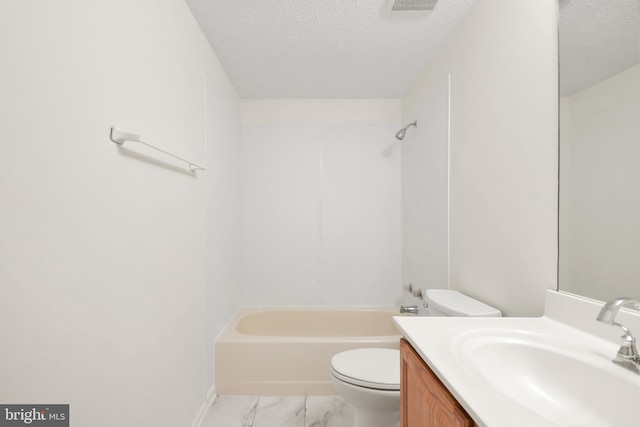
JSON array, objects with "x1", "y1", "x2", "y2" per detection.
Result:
[{"x1": 394, "y1": 291, "x2": 640, "y2": 427}]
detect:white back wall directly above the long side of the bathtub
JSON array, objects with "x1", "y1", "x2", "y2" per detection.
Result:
[{"x1": 241, "y1": 100, "x2": 401, "y2": 306}]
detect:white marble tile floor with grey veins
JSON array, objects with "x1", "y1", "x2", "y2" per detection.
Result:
[{"x1": 200, "y1": 396, "x2": 353, "y2": 427}]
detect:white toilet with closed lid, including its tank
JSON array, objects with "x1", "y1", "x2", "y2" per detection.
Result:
[{"x1": 331, "y1": 289, "x2": 502, "y2": 427}]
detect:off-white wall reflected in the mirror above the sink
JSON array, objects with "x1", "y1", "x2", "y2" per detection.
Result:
[{"x1": 560, "y1": 65, "x2": 640, "y2": 301}]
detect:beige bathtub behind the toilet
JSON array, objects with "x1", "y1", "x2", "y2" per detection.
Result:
[{"x1": 215, "y1": 307, "x2": 400, "y2": 396}]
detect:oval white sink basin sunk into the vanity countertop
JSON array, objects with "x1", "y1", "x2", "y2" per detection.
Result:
[{"x1": 451, "y1": 328, "x2": 640, "y2": 426}]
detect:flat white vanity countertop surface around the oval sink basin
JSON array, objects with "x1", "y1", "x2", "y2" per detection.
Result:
[{"x1": 394, "y1": 316, "x2": 624, "y2": 427}]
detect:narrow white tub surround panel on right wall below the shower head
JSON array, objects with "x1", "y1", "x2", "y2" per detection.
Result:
[{"x1": 401, "y1": 76, "x2": 449, "y2": 308}]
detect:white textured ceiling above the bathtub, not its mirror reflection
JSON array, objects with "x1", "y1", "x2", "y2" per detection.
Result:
[{"x1": 186, "y1": 0, "x2": 475, "y2": 98}]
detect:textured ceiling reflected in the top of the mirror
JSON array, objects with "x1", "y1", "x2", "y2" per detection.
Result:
[{"x1": 559, "y1": 0, "x2": 640, "y2": 95}]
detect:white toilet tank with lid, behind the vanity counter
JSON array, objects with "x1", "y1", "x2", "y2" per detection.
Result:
[{"x1": 425, "y1": 289, "x2": 502, "y2": 317}]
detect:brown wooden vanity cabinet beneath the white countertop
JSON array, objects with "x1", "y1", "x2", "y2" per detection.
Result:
[{"x1": 400, "y1": 338, "x2": 477, "y2": 427}]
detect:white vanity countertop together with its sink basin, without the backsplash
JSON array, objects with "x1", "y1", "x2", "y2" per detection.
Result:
[{"x1": 394, "y1": 314, "x2": 640, "y2": 427}]
